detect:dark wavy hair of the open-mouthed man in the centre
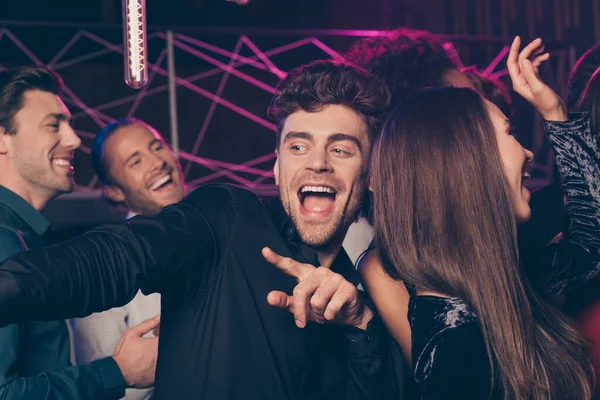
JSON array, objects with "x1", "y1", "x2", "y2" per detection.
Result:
[{"x1": 268, "y1": 60, "x2": 390, "y2": 148}]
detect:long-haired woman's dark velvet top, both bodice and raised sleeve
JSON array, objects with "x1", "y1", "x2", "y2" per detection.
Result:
[{"x1": 407, "y1": 114, "x2": 600, "y2": 400}]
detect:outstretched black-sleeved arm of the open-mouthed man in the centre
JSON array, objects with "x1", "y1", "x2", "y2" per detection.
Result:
[{"x1": 0, "y1": 202, "x2": 215, "y2": 326}]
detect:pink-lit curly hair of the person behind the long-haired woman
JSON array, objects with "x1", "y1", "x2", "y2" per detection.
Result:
[{"x1": 345, "y1": 28, "x2": 458, "y2": 103}]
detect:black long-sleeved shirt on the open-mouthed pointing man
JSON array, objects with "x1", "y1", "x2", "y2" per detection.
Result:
[{"x1": 0, "y1": 184, "x2": 396, "y2": 400}]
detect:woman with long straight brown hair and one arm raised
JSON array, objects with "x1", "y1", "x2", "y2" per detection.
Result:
[{"x1": 361, "y1": 38, "x2": 600, "y2": 400}]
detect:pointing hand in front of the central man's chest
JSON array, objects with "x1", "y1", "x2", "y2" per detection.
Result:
[{"x1": 262, "y1": 247, "x2": 373, "y2": 329}]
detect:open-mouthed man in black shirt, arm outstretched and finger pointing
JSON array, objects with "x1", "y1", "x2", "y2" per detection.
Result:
[{"x1": 0, "y1": 61, "x2": 398, "y2": 400}]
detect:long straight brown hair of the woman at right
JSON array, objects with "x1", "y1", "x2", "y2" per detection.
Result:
[{"x1": 371, "y1": 88, "x2": 593, "y2": 399}]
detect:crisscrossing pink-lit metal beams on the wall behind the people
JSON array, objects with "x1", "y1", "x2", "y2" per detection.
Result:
[{"x1": 0, "y1": 28, "x2": 562, "y2": 190}]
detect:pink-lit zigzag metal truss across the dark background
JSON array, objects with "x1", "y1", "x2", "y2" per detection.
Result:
[{"x1": 0, "y1": 27, "x2": 574, "y2": 192}]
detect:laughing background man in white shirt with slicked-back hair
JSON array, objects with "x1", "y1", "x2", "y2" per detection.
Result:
[{"x1": 73, "y1": 118, "x2": 187, "y2": 400}]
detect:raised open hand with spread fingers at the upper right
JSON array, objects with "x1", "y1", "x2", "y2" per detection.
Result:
[{"x1": 506, "y1": 36, "x2": 567, "y2": 121}]
